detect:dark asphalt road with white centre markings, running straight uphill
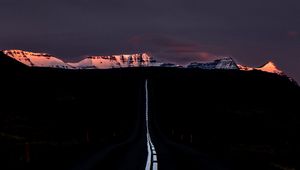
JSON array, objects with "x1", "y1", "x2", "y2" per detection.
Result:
[{"x1": 72, "y1": 80, "x2": 230, "y2": 170}]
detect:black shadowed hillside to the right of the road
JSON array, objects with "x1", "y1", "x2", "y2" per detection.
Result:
[{"x1": 150, "y1": 69, "x2": 300, "y2": 170}]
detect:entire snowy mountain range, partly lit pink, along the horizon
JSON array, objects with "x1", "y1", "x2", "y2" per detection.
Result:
[{"x1": 2, "y1": 50, "x2": 284, "y2": 75}]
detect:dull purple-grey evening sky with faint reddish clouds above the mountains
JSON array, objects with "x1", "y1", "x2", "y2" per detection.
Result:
[{"x1": 0, "y1": 0, "x2": 300, "y2": 82}]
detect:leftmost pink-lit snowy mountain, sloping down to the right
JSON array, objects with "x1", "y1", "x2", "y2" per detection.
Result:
[{"x1": 2, "y1": 50, "x2": 71, "y2": 69}]
